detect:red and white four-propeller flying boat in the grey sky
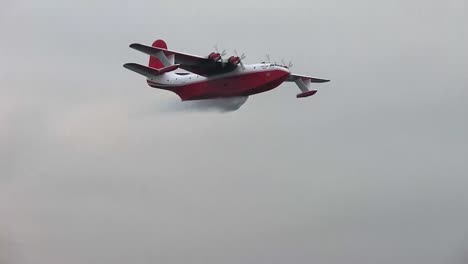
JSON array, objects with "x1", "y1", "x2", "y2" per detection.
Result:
[{"x1": 123, "y1": 39, "x2": 329, "y2": 101}]
